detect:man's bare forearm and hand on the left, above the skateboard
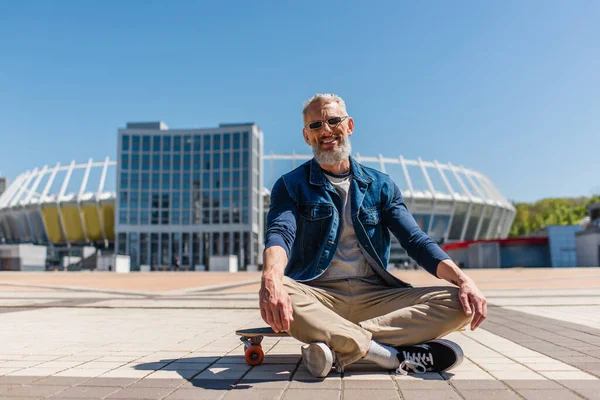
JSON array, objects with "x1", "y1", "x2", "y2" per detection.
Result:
[{"x1": 258, "y1": 276, "x2": 294, "y2": 332}]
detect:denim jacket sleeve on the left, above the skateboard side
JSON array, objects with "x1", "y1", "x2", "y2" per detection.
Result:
[{"x1": 265, "y1": 178, "x2": 298, "y2": 260}]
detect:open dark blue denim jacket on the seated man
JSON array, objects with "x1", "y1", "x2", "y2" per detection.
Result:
[{"x1": 265, "y1": 157, "x2": 449, "y2": 287}]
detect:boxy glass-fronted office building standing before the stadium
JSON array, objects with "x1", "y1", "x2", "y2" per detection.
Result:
[{"x1": 116, "y1": 123, "x2": 263, "y2": 270}]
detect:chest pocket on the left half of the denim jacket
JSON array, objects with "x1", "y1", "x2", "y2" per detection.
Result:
[{"x1": 297, "y1": 204, "x2": 333, "y2": 252}]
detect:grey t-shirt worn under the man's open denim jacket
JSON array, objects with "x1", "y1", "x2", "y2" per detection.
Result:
[{"x1": 316, "y1": 171, "x2": 376, "y2": 281}]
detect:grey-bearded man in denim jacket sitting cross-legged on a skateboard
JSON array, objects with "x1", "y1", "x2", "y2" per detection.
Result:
[{"x1": 259, "y1": 94, "x2": 487, "y2": 377}]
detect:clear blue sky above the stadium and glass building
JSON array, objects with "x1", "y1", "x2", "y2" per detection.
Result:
[{"x1": 0, "y1": 0, "x2": 600, "y2": 201}]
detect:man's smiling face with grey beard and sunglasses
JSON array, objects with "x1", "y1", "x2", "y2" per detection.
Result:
[{"x1": 302, "y1": 102, "x2": 354, "y2": 165}]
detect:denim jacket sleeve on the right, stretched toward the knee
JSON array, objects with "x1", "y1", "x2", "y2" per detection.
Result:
[{"x1": 383, "y1": 182, "x2": 450, "y2": 277}]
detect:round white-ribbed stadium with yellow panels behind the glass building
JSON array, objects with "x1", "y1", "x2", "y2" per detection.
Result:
[{"x1": 0, "y1": 148, "x2": 515, "y2": 269}]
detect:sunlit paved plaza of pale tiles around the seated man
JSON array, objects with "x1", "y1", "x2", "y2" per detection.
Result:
[{"x1": 0, "y1": 268, "x2": 600, "y2": 400}]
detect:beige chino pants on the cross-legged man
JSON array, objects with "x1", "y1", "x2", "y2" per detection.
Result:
[{"x1": 283, "y1": 277, "x2": 471, "y2": 367}]
